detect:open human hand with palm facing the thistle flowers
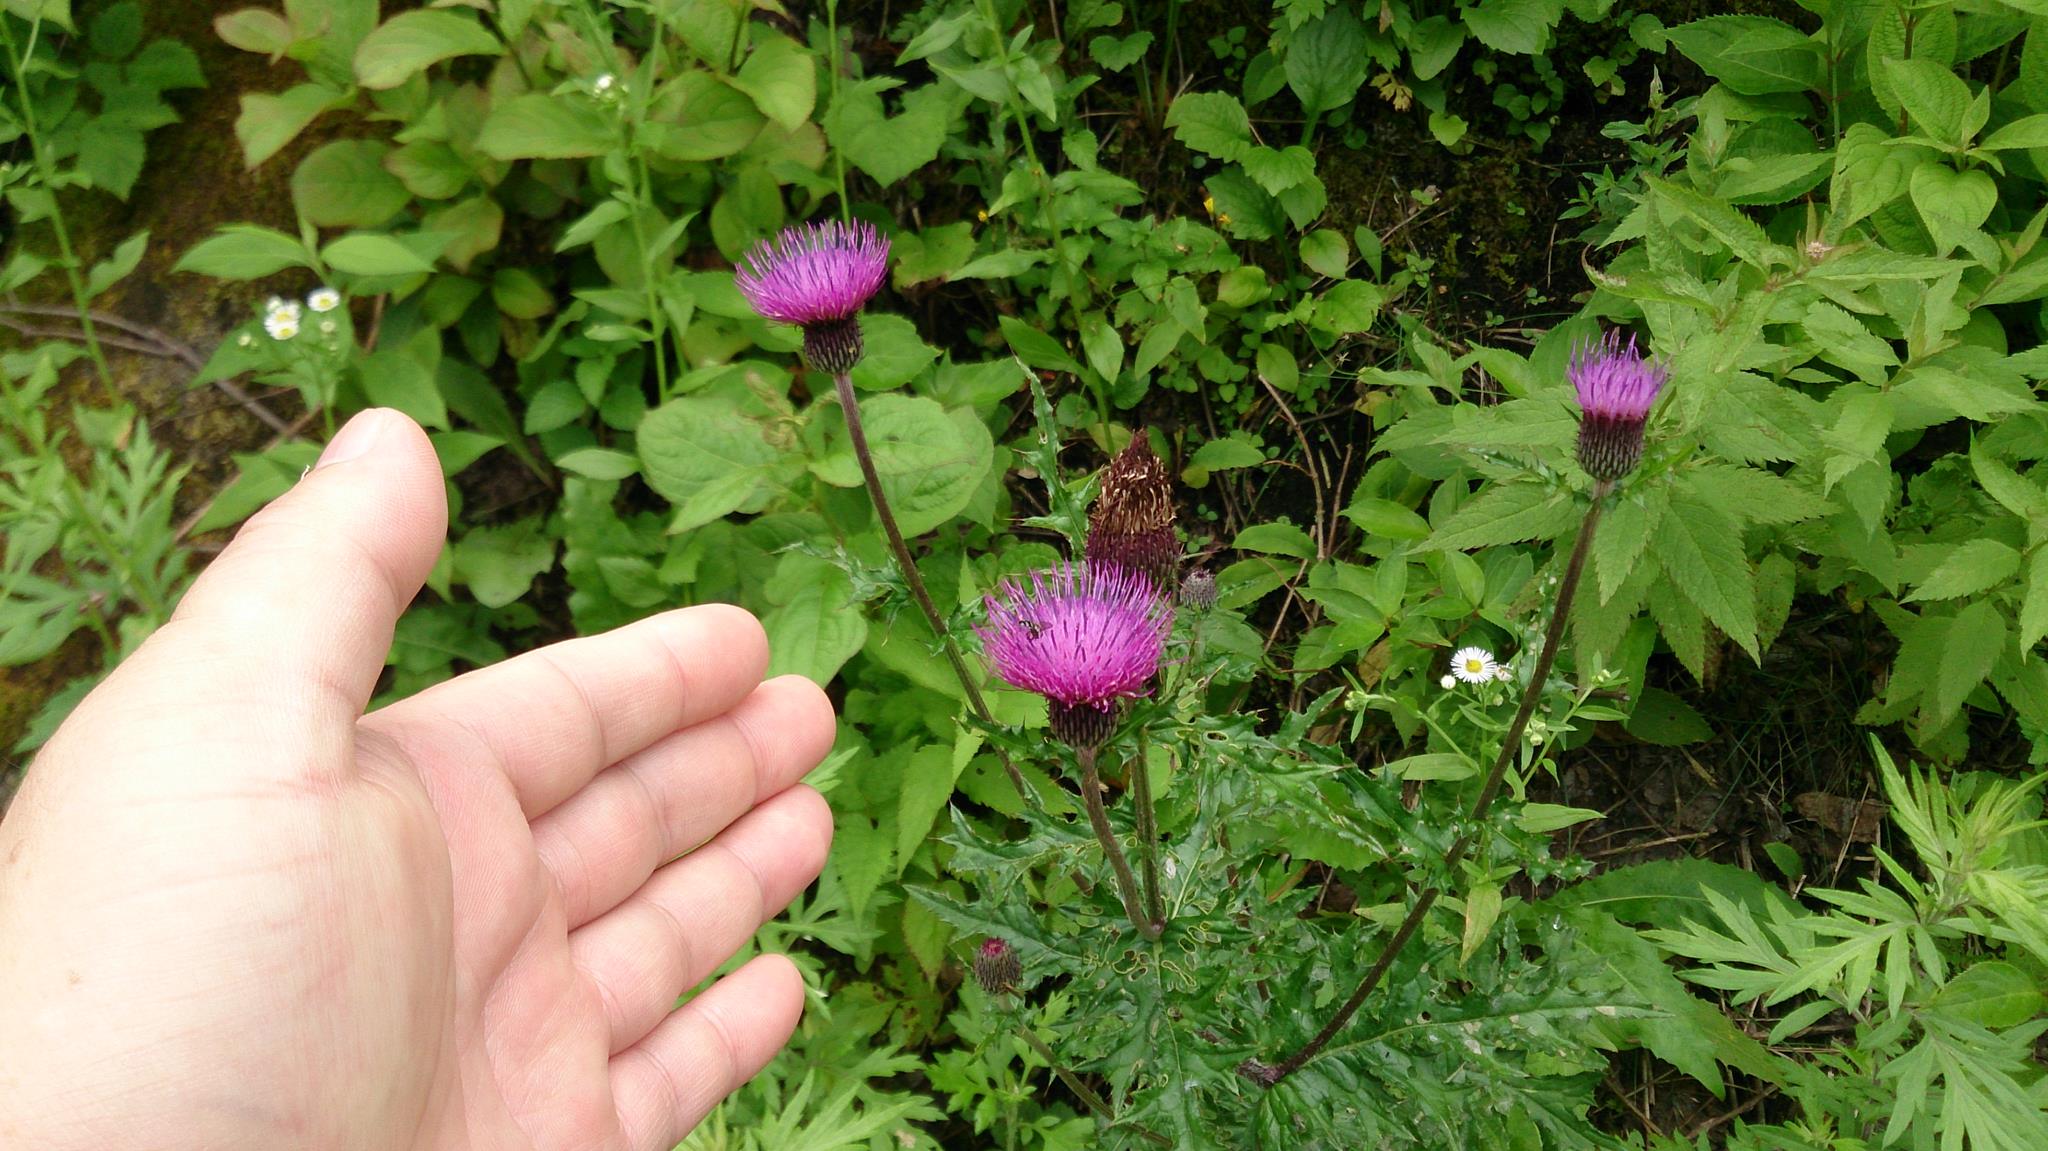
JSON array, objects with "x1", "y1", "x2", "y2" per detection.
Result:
[{"x1": 0, "y1": 412, "x2": 834, "y2": 1151}]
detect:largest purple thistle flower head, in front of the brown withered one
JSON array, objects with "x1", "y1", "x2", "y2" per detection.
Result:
[{"x1": 975, "y1": 563, "x2": 1174, "y2": 748}]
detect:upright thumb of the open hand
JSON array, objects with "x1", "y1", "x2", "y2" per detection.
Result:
[{"x1": 116, "y1": 408, "x2": 449, "y2": 729}]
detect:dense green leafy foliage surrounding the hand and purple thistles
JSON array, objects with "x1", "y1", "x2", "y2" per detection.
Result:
[{"x1": 12, "y1": 0, "x2": 2048, "y2": 1151}]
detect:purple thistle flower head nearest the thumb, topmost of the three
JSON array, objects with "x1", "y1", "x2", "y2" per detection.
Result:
[{"x1": 733, "y1": 219, "x2": 889, "y2": 375}]
